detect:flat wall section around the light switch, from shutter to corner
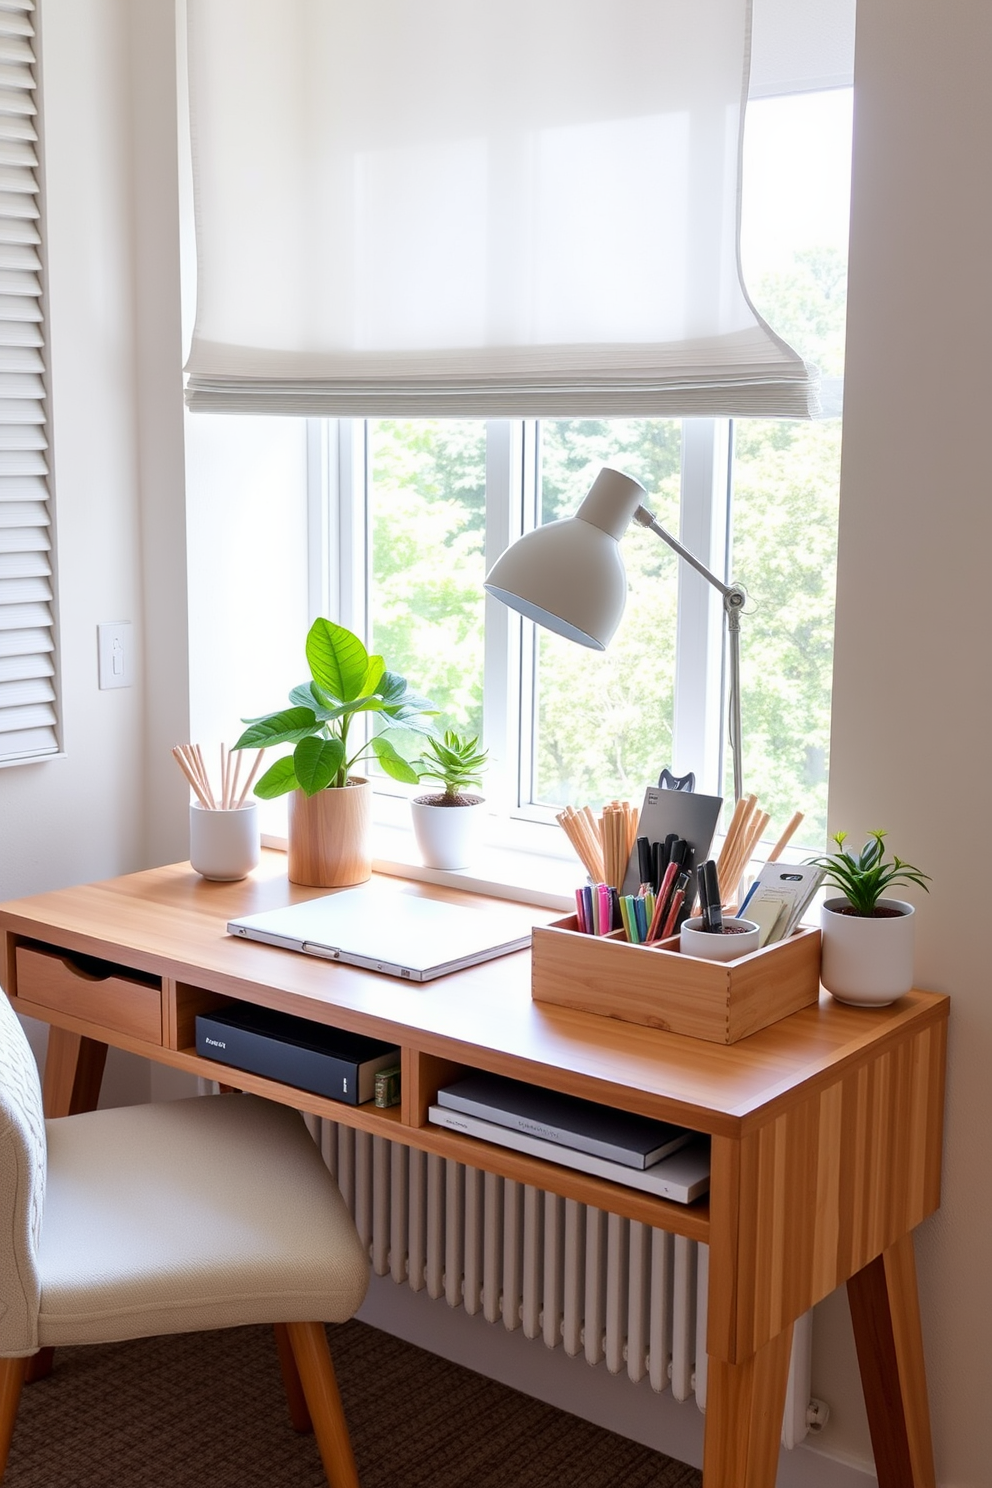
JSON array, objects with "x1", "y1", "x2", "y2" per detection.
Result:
[{"x1": 0, "y1": 0, "x2": 144, "y2": 899}]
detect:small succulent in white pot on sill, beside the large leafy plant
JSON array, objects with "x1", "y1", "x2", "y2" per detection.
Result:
[{"x1": 410, "y1": 729, "x2": 488, "y2": 869}]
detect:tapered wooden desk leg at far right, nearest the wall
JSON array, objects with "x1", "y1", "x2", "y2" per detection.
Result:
[{"x1": 848, "y1": 1232, "x2": 935, "y2": 1488}]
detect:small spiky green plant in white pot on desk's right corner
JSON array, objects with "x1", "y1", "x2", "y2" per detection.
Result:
[{"x1": 808, "y1": 832, "x2": 930, "y2": 1007}]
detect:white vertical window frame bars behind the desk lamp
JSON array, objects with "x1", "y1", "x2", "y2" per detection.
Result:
[{"x1": 308, "y1": 418, "x2": 732, "y2": 856}]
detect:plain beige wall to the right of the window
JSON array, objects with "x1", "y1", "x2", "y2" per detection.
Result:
[{"x1": 818, "y1": 0, "x2": 992, "y2": 1488}]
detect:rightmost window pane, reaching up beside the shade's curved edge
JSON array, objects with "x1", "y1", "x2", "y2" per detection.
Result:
[{"x1": 732, "y1": 89, "x2": 852, "y2": 850}]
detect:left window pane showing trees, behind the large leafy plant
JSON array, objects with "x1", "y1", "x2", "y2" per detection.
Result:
[{"x1": 369, "y1": 420, "x2": 486, "y2": 753}]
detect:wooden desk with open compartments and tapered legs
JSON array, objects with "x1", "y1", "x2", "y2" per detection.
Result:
[{"x1": 0, "y1": 853, "x2": 947, "y2": 1488}]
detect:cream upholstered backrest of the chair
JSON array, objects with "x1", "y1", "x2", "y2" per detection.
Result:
[{"x1": 0, "y1": 988, "x2": 48, "y2": 1357}]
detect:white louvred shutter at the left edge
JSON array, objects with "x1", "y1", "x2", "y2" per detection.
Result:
[{"x1": 0, "y1": 0, "x2": 58, "y2": 763}]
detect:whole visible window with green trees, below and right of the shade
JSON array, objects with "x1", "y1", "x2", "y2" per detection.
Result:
[{"x1": 310, "y1": 89, "x2": 851, "y2": 848}]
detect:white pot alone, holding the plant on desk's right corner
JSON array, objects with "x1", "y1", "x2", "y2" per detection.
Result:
[{"x1": 819, "y1": 899, "x2": 915, "y2": 1007}]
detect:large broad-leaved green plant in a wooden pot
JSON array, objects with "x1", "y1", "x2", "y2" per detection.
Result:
[{"x1": 233, "y1": 619, "x2": 434, "y2": 888}]
